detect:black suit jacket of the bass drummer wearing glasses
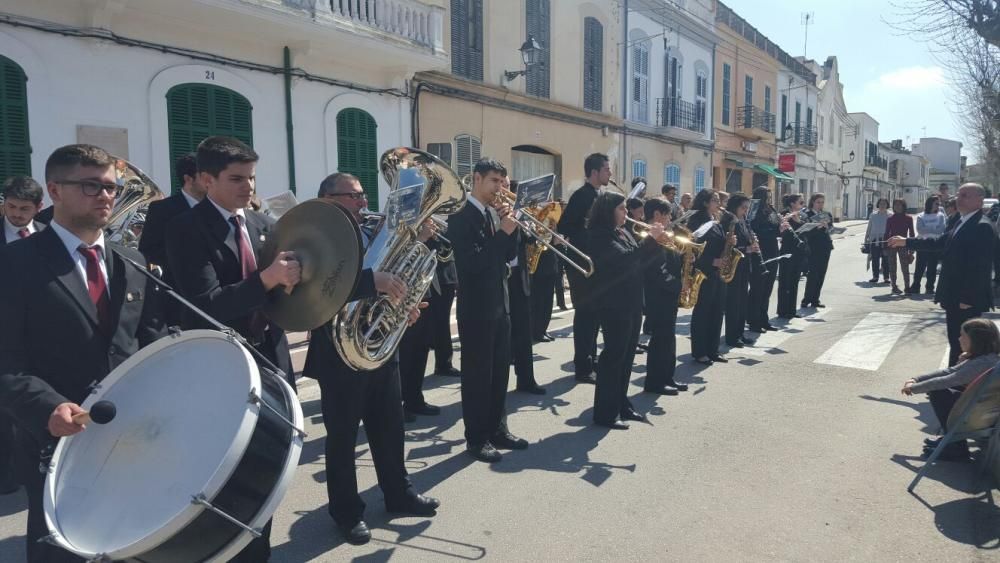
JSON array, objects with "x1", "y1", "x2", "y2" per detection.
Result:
[{"x1": 0, "y1": 229, "x2": 163, "y2": 446}]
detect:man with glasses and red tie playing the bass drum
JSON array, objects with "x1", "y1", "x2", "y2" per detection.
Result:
[{"x1": 0, "y1": 145, "x2": 163, "y2": 563}]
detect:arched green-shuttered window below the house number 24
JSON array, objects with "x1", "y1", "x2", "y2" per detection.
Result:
[{"x1": 167, "y1": 84, "x2": 253, "y2": 191}]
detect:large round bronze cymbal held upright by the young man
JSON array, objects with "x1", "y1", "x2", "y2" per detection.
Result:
[{"x1": 261, "y1": 199, "x2": 364, "y2": 331}]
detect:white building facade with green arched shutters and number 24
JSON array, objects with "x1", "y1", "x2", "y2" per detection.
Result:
[{"x1": 0, "y1": 0, "x2": 448, "y2": 208}]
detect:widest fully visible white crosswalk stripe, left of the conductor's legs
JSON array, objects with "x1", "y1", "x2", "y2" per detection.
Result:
[{"x1": 815, "y1": 313, "x2": 913, "y2": 371}]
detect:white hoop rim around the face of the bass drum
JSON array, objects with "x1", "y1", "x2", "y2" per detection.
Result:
[{"x1": 42, "y1": 329, "x2": 261, "y2": 560}]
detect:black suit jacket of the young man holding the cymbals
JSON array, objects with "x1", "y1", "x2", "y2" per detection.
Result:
[{"x1": 167, "y1": 197, "x2": 294, "y2": 381}]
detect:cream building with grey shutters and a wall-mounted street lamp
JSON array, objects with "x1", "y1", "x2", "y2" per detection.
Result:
[{"x1": 413, "y1": 0, "x2": 630, "y2": 199}]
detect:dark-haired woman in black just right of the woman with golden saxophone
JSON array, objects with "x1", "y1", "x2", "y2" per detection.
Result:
[{"x1": 723, "y1": 193, "x2": 759, "y2": 348}]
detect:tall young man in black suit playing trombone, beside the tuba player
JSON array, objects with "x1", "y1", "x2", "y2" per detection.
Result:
[{"x1": 448, "y1": 158, "x2": 528, "y2": 463}]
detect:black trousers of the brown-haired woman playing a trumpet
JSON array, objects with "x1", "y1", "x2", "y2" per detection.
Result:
[{"x1": 594, "y1": 308, "x2": 639, "y2": 424}]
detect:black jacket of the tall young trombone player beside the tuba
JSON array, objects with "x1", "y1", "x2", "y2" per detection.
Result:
[{"x1": 448, "y1": 203, "x2": 517, "y2": 320}]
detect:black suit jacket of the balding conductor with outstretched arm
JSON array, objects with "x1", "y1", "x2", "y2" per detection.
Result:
[{"x1": 906, "y1": 211, "x2": 996, "y2": 311}]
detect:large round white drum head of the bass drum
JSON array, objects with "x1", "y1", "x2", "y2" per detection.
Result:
[{"x1": 44, "y1": 330, "x2": 261, "y2": 559}]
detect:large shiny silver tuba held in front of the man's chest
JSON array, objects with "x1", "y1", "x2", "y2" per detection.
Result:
[{"x1": 331, "y1": 147, "x2": 468, "y2": 371}]
